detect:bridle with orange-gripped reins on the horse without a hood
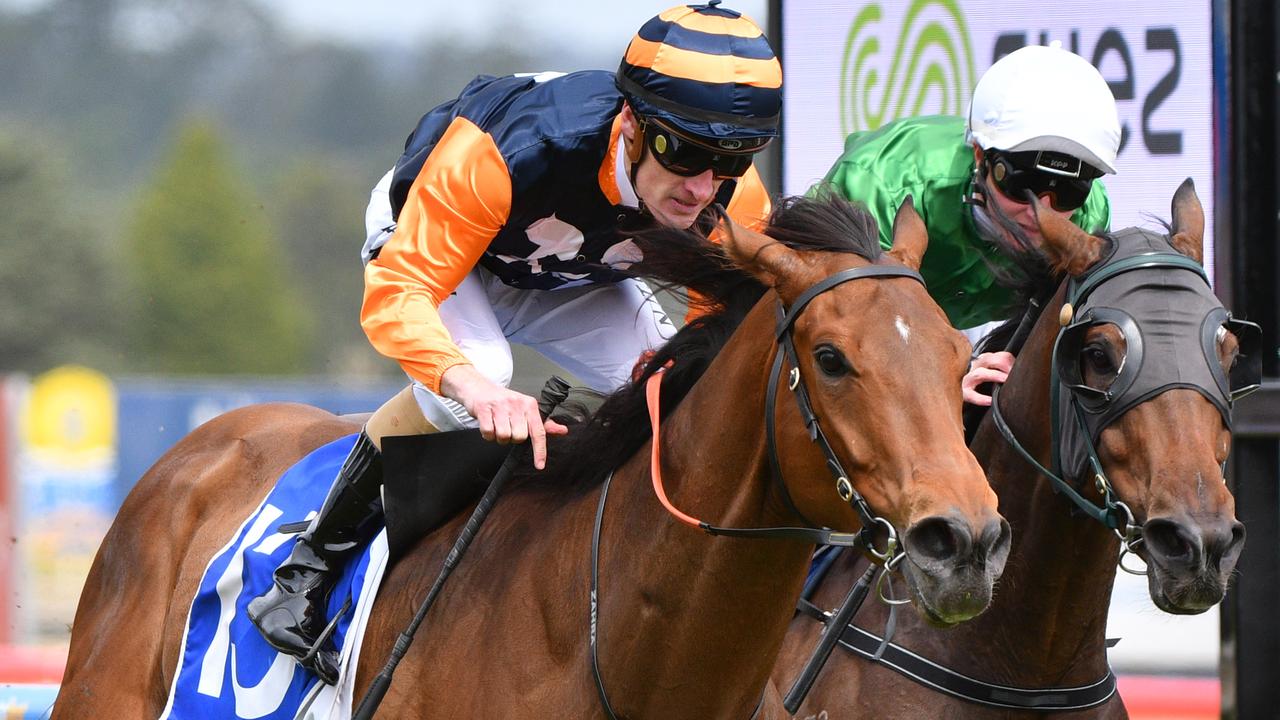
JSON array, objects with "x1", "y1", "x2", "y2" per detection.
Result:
[{"x1": 590, "y1": 260, "x2": 924, "y2": 720}]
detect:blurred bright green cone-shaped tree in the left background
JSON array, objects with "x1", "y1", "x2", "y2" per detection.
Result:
[{"x1": 125, "y1": 122, "x2": 310, "y2": 374}]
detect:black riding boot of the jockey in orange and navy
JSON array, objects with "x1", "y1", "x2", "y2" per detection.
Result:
[{"x1": 248, "y1": 432, "x2": 383, "y2": 685}]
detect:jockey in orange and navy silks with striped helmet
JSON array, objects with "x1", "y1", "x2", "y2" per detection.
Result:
[{"x1": 248, "y1": 0, "x2": 782, "y2": 683}]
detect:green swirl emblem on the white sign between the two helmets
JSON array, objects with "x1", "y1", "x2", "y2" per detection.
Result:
[{"x1": 840, "y1": 0, "x2": 975, "y2": 135}]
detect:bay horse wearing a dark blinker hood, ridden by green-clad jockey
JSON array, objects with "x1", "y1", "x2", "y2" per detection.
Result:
[{"x1": 774, "y1": 179, "x2": 1257, "y2": 720}]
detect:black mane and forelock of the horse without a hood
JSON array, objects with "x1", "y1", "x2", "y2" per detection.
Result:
[{"x1": 519, "y1": 193, "x2": 881, "y2": 487}]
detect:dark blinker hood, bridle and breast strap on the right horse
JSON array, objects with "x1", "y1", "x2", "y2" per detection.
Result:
[{"x1": 800, "y1": 231, "x2": 1261, "y2": 711}]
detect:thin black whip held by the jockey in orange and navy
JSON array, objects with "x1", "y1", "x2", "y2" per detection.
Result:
[{"x1": 352, "y1": 375, "x2": 570, "y2": 720}]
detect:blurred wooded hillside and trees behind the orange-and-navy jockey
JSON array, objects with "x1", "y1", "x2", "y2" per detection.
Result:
[{"x1": 0, "y1": 0, "x2": 596, "y2": 377}]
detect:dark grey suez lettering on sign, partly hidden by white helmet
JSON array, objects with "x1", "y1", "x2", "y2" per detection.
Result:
[{"x1": 991, "y1": 27, "x2": 1183, "y2": 155}]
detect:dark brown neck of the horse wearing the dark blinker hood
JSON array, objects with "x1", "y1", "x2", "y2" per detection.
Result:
[{"x1": 947, "y1": 297, "x2": 1119, "y2": 685}]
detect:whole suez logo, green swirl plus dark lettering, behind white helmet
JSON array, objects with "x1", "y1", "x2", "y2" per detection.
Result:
[{"x1": 837, "y1": 0, "x2": 1183, "y2": 155}]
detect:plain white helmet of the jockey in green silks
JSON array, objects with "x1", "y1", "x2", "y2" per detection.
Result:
[{"x1": 965, "y1": 42, "x2": 1120, "y2": 174}]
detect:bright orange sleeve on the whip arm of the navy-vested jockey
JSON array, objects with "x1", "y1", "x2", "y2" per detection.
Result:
[{"x1": 360, "y1": 118, "x2": 511, "y2": 392}]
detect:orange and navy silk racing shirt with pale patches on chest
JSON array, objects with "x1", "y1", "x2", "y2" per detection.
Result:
[{"x1": 361, "y1": 70, "x2": 769, "y2": 393}]
